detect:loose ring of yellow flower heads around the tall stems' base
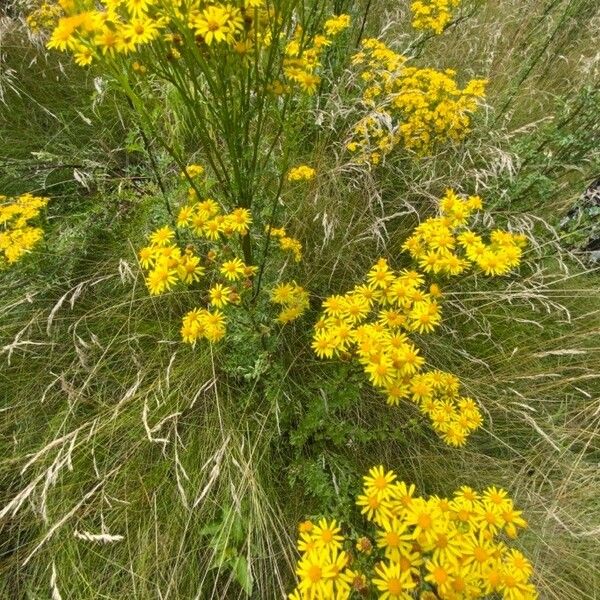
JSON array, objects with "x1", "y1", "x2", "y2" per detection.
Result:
[{"x1": 138, "y1": 164, "x2": 308, "y2": 344}]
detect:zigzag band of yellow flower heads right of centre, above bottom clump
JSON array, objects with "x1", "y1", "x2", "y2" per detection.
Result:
[{"x1": 312, "y1": 190, "x2": 525, "y2": 446}]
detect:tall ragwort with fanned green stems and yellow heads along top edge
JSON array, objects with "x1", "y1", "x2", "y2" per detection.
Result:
[{"x1": 48, "y1": 0, "x2": 350, "y2": 264}]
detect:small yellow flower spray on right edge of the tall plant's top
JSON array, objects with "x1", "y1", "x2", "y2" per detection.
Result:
[{"x1": 283, "y1": 15, "x2": 350, "y2": 94}]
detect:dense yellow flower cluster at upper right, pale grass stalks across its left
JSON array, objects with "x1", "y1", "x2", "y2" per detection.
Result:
[{"x1": 346, "y1": 39, "x2": 486, "y2": 164}]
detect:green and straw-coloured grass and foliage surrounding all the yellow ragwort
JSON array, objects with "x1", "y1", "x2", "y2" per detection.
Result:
[{"x1": 0, "y1": 0, "x2": 600, "y2": 600}]
